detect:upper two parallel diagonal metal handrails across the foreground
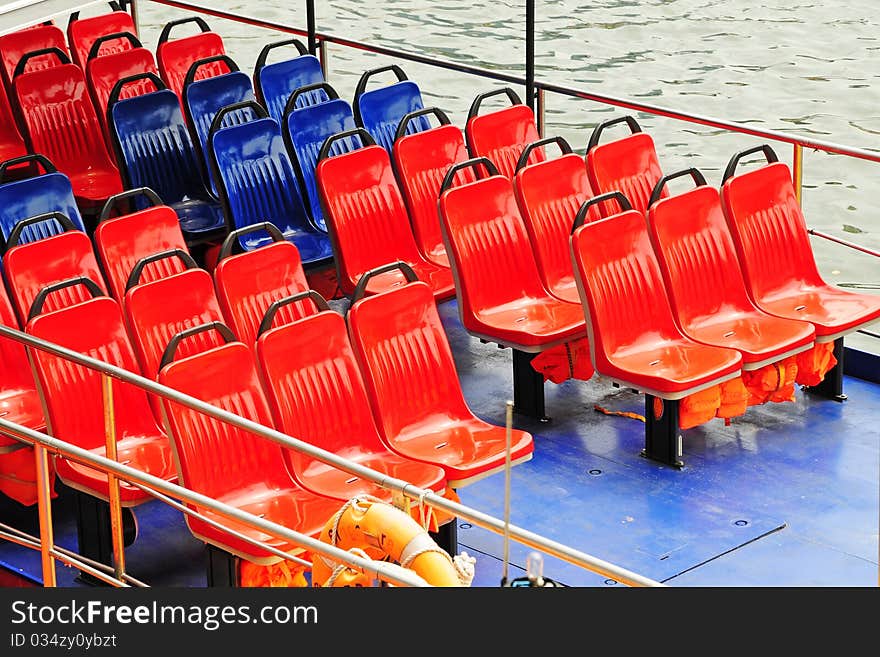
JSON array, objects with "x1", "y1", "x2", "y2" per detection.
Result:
[{"x1": 0, "y1": 325, "x2": 663, "y2": 586}]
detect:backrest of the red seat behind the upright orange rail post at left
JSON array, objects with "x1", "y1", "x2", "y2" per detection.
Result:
[{"x1": 27, "y1": 297, "x2": 160, "y2": 449}]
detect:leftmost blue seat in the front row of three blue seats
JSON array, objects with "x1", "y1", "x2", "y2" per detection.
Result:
[{"x1": 209, "y1": 101, "x2": 333, "y2": 267}]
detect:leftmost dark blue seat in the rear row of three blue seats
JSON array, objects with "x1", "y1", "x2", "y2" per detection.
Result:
[{"x1": 109, "y1": 73, "x2": 226, "y2": 246}]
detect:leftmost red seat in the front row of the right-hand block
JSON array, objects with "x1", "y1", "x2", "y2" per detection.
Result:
[{"x1": 571, "y1": 199, "x2": 742, "y2": 400}]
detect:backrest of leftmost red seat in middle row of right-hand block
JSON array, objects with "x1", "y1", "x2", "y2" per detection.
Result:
[{"x1": 439, "y1": 158, "x2": 547, "y2": 322}]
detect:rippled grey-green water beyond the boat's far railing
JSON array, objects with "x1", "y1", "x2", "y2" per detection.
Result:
[{"x1": 134, "y1": 0, "x2": 880, "y2": 291}]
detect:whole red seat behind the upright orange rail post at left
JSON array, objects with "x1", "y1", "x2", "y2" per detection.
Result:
[{"x1": 27, "y1": 297, "x2": 177, "y2": 506}]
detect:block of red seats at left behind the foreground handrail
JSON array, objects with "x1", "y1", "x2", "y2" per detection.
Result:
[{"x1": 0, "y1": 193, "x2": 532, "y2": 560}]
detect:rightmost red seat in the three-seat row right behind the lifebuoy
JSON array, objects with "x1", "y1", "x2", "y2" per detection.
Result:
[{"x1": 348, "y1": 281, "x2": 534, "y2": 488}]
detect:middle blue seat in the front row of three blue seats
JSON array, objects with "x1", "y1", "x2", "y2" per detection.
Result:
[{"x1": 281, "y1": 82, "x2": 363, "y2": 232}]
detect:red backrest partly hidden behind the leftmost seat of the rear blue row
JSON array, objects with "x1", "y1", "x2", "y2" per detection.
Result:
[{"x1": 85, "y1": 42, "x2": 158, "y2": 141}]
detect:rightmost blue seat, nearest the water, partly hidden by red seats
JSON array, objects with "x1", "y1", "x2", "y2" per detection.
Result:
[{"x1": 354, "y1": 64, "x2": 431, "y2": 155}]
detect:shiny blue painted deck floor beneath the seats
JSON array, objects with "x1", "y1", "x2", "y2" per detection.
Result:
[{"x1": 0, "y1": 301, "x2": 880, "y2": 586}]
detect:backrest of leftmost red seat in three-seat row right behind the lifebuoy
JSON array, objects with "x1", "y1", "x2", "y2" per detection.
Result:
[{"x1": 159, "y1": 342, "x2": 291, "y2": 499}]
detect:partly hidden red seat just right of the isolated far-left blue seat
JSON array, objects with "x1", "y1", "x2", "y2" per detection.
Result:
[{"x1": 95, "y1": 188, "x2": 196, "y2": 303}]
